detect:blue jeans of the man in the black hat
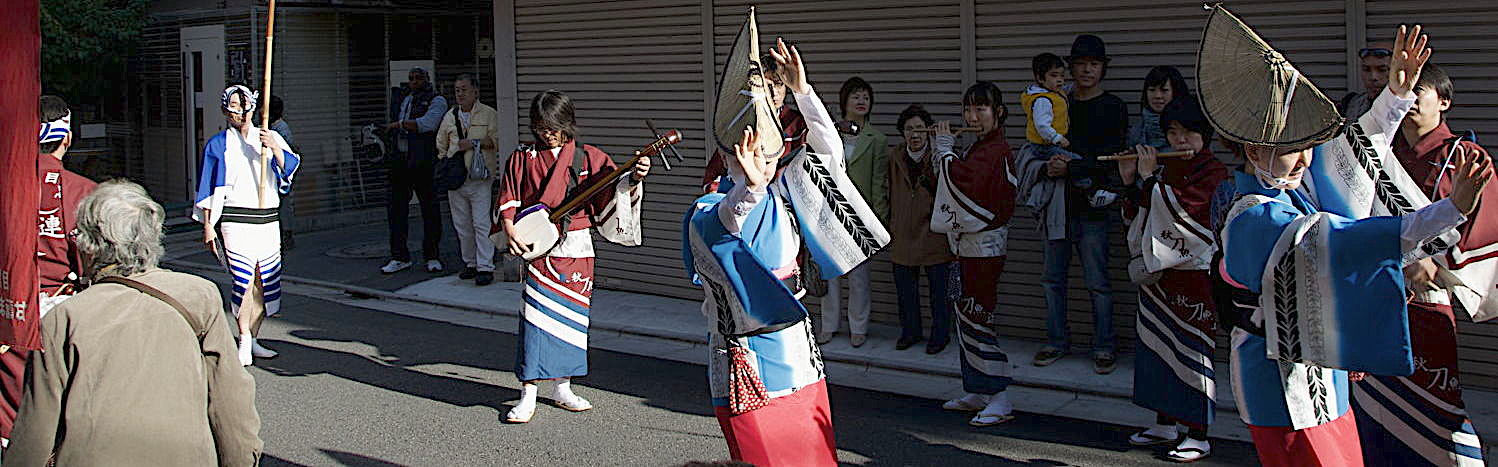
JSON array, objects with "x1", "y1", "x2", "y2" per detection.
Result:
[{"x1": 1041, "y1": 217, "x2": 1115, "y2": 352}]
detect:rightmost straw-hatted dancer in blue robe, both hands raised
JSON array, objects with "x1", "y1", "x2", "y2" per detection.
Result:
[{"x1": 1197, "y1": 6, "x2": 1492, "y2": 466}]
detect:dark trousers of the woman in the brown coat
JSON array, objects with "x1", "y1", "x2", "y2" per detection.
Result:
[{"x1": 894, "y1": 262, "x2": 962, "y2": 346}]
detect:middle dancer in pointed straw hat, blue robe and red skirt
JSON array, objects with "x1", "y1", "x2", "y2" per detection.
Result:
[{"x1": 683, "y1": 10, "x2": 890, "y2": 466}]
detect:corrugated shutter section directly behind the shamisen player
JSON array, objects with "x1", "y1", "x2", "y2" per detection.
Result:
[{"x1": 500, "y1": 0, "x2": 706, "y2": 298}]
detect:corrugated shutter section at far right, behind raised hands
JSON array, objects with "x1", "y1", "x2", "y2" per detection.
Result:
[{"x1": 1354, "y1": 0, "x2": 1498, "y2": 388}]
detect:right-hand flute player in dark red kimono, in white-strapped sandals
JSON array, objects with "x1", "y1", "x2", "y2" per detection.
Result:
[{"x1": 1119, "y1": 96, "x2": 1228, "y2": 463}]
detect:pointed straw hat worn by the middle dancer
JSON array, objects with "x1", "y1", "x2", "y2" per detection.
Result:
[{"x1": 713, "y1": 6, "x2": 785, "y2": 156}]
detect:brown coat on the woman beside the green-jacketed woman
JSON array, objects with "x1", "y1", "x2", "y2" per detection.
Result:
[{"x1": 887, "y1": 141, "x2": 956, "y2": 266}]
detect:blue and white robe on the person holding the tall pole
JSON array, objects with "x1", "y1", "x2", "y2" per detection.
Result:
[{"x1": 192, "y1": 124, "x2": 301, "y2": 316}]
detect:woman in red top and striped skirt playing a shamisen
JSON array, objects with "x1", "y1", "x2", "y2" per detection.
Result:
[{"x1": 494, "y1": 90, "x2": 650, "y2": 424}]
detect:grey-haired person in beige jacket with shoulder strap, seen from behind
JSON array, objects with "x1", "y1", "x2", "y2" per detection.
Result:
[{"x1": 4, "y1": 181, "x2": 262, "y2": 466}]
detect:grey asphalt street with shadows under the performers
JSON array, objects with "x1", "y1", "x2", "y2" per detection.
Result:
[{"x1": 239, "y1": 290, "x2": 1255, "y2": 466}]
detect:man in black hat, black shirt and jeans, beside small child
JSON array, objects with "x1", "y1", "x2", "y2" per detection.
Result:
[{"x1": 1034, "y1": 34, "x2": 1128, "y2": 374}]
